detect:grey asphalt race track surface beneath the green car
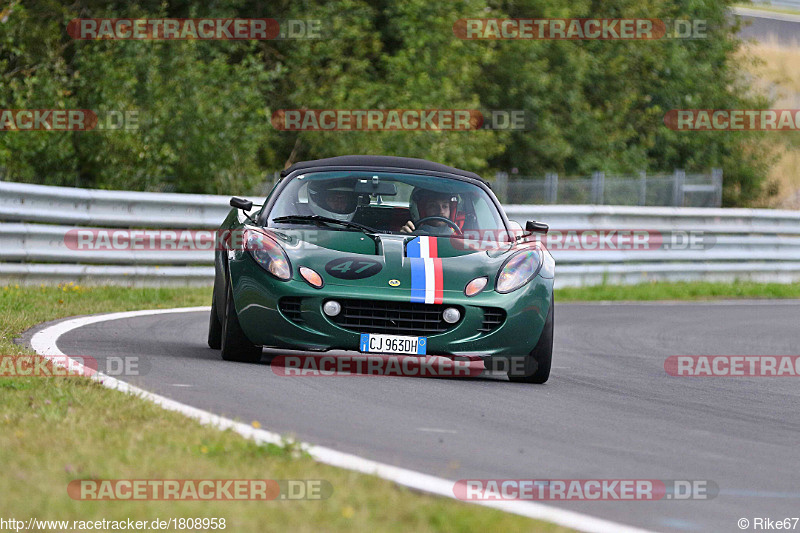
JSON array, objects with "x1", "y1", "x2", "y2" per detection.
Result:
[{"x1": 34, "y1": 300, "x2": 800, "y2": 531}]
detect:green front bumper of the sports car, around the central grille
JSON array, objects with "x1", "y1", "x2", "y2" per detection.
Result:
[{"x1": 229, "y1": 254, "x2": 553, "y2": 359}]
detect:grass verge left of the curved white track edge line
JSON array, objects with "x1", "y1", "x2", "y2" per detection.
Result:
[{"x1": 0, "y1": 284, "x2": 569, "y2": 532}]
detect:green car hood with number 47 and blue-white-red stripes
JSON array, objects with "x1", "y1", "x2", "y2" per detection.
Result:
[{"x1": 266, "y1": 228, "x2": 536, "y2": 290}]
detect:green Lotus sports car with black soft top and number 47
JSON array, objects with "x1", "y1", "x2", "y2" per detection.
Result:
[{"x1": 208, "y1": 156, "x2": 555, "y2": 383}]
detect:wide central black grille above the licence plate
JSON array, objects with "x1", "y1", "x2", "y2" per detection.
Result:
[{"x1": 332, "y1": 300, "x2": 464, "y2": 335}]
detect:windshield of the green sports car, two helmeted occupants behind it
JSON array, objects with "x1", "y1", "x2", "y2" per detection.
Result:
[{"x1": 267, "y1": 171, "x2": 505, "y2": 235}]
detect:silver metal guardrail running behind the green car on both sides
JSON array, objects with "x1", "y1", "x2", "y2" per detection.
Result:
[{"x1": 0, "y1": 182, "x2": 800, "y2": 286}]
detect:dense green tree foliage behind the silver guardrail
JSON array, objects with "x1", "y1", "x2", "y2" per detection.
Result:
[{"x1": 0, "y1": 0, "x2": 770, "y2": 205}]
